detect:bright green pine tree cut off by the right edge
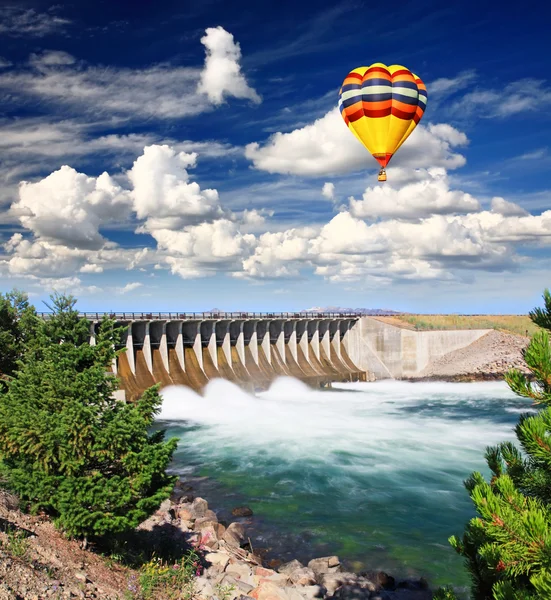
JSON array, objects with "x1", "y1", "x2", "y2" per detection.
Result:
[{"x1": 436, "y1": 290, "x2": 551, "y2": 600}]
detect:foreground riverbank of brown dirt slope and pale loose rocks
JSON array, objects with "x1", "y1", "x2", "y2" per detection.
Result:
[{"x1": 0, "y1": 483, "x2": 438, "y2": 600}]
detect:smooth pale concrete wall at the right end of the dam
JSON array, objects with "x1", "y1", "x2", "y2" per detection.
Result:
[{"x1": 350, "y1": 317, "x2": 491, "y2": 379}]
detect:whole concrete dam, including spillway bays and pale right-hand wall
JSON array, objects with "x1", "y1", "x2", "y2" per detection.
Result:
[{"x1": 82, "y1": 313, "x2": 489, "y2": 400}]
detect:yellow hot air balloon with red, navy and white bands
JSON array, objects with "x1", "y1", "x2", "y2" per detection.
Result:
[{"x1": 339, "y1": 63, "x2": 427, "y2": 181}]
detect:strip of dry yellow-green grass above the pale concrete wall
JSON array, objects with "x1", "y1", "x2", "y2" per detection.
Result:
[{"x1": 374, "y1": 314, "x2": 540, "y2": 336}]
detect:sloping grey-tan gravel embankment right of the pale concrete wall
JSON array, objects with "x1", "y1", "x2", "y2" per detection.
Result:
[{"x1": 411, "y1": 331, "x2": 529, "y2": 381}]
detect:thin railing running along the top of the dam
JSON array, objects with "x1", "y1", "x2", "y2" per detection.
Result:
[{"x1": 38, "y1": 312, "x2": 368, "y2": 321}]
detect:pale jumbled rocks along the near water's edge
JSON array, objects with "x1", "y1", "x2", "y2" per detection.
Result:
[{"x1": 146, "y1": 482, "x2": 432, "y2": 600}]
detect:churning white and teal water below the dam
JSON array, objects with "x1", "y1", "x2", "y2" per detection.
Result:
[{"x1": 159, "y1": 378, "x2": 530, "y2": 583}]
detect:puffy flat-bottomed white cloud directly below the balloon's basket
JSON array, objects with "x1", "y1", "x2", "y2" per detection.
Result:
[{"x1": 350, "y1": 168, "x2": 480, "y2": 219}]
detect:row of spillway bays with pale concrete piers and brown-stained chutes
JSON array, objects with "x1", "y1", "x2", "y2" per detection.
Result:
[{"x1": 87, "y1": 313, "x2": 366, "y2": 400}]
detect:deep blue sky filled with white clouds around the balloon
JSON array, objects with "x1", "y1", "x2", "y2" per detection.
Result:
[{"x1": 0, "y1": 0, "x2": 551, "y2": 313}]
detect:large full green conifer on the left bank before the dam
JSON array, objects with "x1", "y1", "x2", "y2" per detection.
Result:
[{"x1": 0, "y1": 295, "x2": 176, "y2": 538}]
